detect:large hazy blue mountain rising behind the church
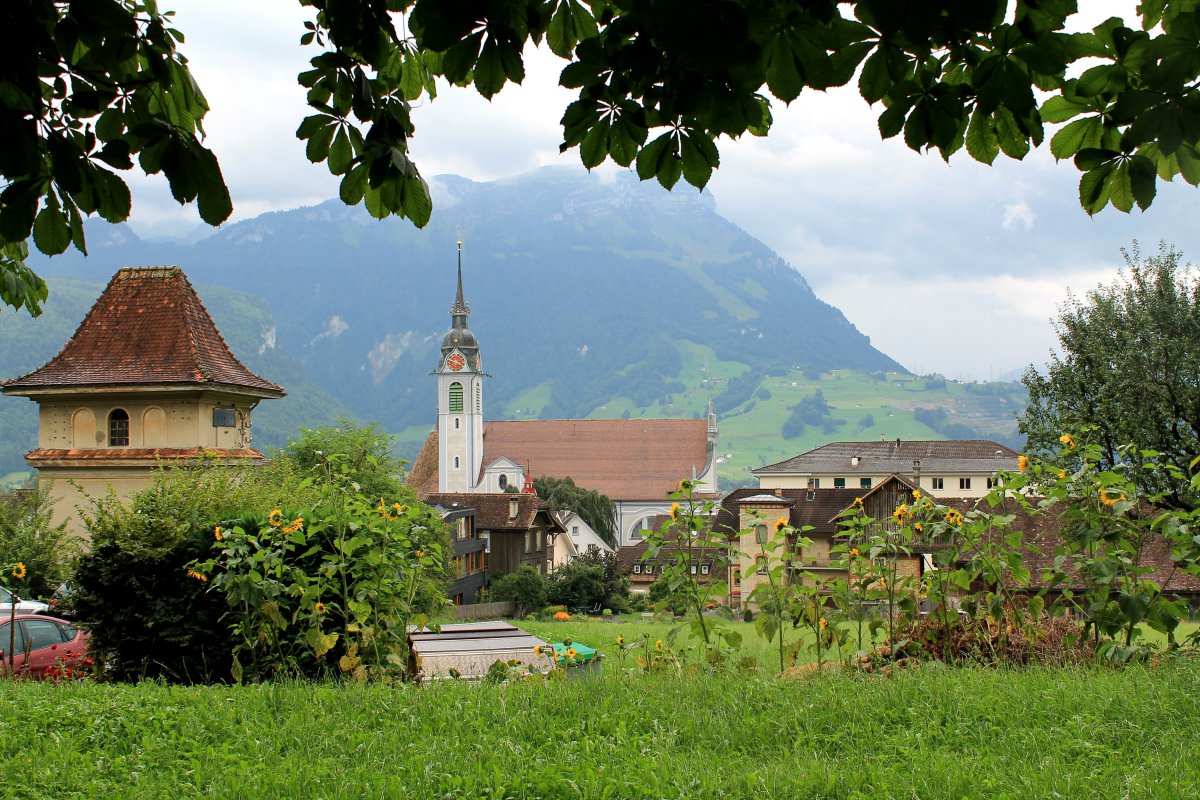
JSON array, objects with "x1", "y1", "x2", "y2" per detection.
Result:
[{"x1": 0, "y1": 168, "x2": 964, "y2": 479}]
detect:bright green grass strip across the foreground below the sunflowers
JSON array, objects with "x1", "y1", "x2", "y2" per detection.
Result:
[{"x1": 0, "y1": 662, "x2": 1200, "y2": 800}]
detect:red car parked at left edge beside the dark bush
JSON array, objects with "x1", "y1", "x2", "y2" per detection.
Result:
[{"x1": 0, "y1": 614, "x2": 91, "y2": 679}]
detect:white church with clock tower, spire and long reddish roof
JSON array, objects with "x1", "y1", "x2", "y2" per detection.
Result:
[{"x1": 409, "y1": 242, "x2": 718, "y2": 546}]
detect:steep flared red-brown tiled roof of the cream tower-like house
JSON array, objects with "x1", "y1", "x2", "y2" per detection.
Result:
[{"x1": 2, "y1": 266, "x2": 284, "y2": 397}]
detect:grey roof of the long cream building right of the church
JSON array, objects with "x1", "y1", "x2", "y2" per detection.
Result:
[{"x1": 750, "y1": 439, "x2": 1018, "y2": 475}]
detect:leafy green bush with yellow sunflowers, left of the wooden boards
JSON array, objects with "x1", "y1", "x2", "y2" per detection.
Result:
[{"x1": 190, "y1": 489, "x2": 451, "y2": 681}]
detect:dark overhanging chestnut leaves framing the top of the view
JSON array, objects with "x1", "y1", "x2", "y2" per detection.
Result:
[{"x1": 7, "y1": 0, "x2": 1200, "y2": 313}]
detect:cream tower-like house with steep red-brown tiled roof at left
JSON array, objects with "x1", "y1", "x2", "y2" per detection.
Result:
[{"x1": 0, "y1": 266, "x2": 284, "y2": 534}]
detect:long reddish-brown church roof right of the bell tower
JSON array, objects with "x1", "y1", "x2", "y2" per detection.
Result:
[{"x1": 484, "y1": 420, "x2": 708, "y2": 500}]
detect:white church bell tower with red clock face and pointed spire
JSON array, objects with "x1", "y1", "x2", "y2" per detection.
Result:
[{"x1": 434, "y1": 240, "x2": 484, "y2": 492}]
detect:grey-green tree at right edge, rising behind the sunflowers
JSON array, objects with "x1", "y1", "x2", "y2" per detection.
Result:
[{"x1": 1019, "y1": 243, "x2": 1200, "y2": 507}]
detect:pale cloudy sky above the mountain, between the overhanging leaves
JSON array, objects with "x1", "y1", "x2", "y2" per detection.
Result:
[{"x1": 121, "y1": 0, "x2": 1200, "y2": 379}]
